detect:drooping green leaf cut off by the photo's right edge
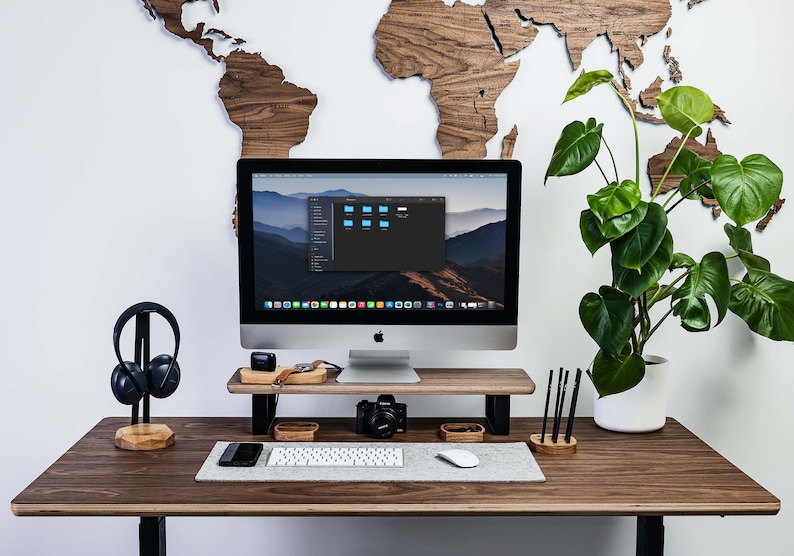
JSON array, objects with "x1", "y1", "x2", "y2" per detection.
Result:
[{"x1": 729, "y1": 269, "x2": 794, "y2": 341}]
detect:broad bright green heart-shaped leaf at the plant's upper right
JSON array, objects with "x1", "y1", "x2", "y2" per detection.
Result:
[{"x1": 711, "y1": 154, "x2": 783, "y2": 228}]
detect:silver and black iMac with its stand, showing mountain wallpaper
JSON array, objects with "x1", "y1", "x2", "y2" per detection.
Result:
[{"x1": 237, "y1": 159, "x2": 521, "y2": 383}]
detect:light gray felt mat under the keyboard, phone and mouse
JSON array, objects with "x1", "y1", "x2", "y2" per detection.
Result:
[{"x1": 195, "y1": 442, "x2": 546, "y2": 483}]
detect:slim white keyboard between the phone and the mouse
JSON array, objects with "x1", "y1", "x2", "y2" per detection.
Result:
[{"x1": 267, "y1": 446, "x2": 403, "y2": 467}]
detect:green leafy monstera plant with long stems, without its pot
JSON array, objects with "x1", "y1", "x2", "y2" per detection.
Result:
[{"x1": 544, "y1": 70, "x2": 794, "y2": 397}]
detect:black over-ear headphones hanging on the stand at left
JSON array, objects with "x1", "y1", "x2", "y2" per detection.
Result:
[{"x1": 110, "y1": 301, "x2": 180, "y2": 405}]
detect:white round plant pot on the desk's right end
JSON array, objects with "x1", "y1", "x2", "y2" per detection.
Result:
[{"x1": 593, "y1": 355, "x2": 669, "y2": 432}]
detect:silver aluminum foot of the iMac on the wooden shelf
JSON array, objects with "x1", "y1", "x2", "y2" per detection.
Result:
[{"x1": 336, "y1": 349, "x2": 419, "y2": 384}]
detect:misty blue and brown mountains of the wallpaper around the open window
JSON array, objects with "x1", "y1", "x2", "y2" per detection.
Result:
[{"x1": 253, "y1": 190, "x2": 506, "y2": 309}]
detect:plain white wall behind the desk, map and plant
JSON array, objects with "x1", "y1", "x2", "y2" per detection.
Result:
[{"x1": 0, "y1": 0, "x2": 794, "y2": 556}]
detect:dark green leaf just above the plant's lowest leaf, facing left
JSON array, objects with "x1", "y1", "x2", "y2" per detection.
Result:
[{"x1": 579, "y1": 286, "x2": 634, "y2": 357}]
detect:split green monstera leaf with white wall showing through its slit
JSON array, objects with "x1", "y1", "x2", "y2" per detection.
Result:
[{"x1": 673, "y1": 252, "x2": 731, "y2": 332}]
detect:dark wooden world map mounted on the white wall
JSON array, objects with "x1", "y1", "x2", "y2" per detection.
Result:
[{"x1": 137, "y1": 0, "x2": 783, "y2": 228}]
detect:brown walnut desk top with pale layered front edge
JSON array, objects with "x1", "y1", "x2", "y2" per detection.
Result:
[{"x1": 11, "y1": 417, "x2": 780, "y2": 516}]
